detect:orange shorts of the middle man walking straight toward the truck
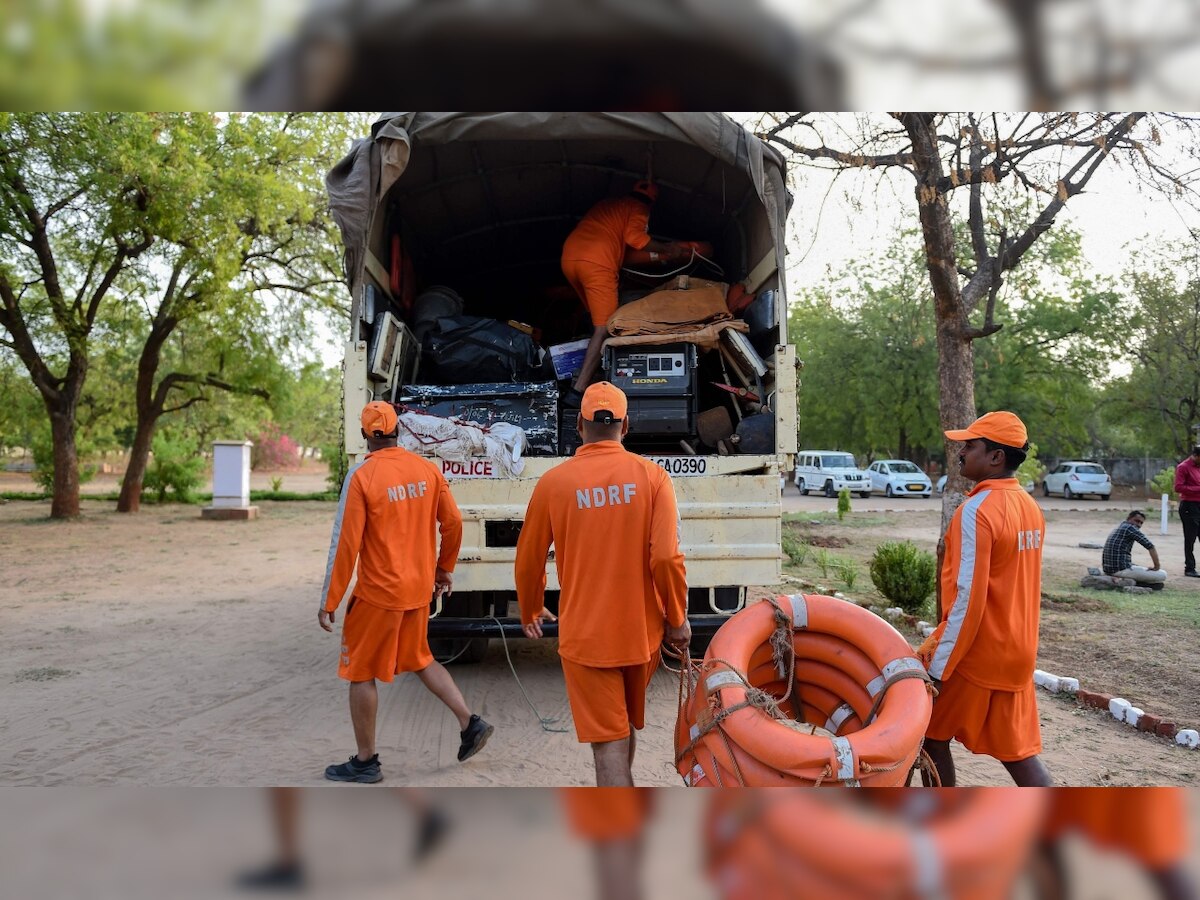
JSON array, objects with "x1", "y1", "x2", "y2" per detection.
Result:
[{"x1": 563, "y1": 653, "x2": 659, "y2": 744}]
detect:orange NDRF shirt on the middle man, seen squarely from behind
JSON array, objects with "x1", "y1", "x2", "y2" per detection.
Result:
[{"x1": 516, "y1": 440, "x2": 688, "y2": 668}]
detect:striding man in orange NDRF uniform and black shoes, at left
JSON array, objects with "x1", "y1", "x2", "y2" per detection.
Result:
[{"x1": 317, "y1": 401, "x2": 492, "y2": 784}]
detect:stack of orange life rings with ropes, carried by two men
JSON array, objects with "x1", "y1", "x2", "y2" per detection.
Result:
[{"x1": 676, "y1": 594, "x2": 934, "y2": 787}]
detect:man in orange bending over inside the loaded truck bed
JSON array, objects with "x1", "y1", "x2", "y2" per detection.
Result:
[{"x1": 562, "y1": 181, "x2": 688, "y2": 406}]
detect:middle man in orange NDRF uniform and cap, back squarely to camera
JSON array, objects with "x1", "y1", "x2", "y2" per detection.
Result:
[{"x1": 516, "y1": 382, "x2": 691, "y2": 787}]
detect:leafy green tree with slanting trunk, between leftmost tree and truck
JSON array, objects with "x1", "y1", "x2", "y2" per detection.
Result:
[{"x1": 116, "y1": 115, "x2": 347, "y2": 512}]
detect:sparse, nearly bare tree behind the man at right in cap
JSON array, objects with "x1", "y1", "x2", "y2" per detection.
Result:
[{"x1": 758, "y1": 113, "x2": 1194, "y2": 523}]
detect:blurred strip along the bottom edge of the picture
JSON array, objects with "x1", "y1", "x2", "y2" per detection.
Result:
[{"x1": 0, "y1": 788, "x2": 1200, "y2": 900}]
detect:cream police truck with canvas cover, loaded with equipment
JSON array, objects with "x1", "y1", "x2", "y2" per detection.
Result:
[{"x1": 326, "y1": 113, "x2": 797, "y2": 661}]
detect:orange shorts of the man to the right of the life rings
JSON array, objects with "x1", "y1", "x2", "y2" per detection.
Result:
[{"x1": 925, "y1": 674, "x2": 1042, "y2": 762}]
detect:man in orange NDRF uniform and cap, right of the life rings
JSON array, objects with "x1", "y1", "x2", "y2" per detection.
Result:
[{"x1": 920, "y1": 412, "x2": 1051, "y2": 787}]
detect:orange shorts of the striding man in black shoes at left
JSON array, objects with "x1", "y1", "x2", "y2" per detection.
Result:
[{"x1": 337, "y1": 596, "x2": 433, "y2": 682}]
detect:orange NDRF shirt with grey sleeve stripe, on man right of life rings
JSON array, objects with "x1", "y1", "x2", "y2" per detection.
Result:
[{"x1": 929, "y1": 478, "x2": 1045, "y2": 691}]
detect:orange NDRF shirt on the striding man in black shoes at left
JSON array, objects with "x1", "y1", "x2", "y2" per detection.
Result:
[{"x1": 322, "y1": 446, "x2": 462, "y2": 612}]
